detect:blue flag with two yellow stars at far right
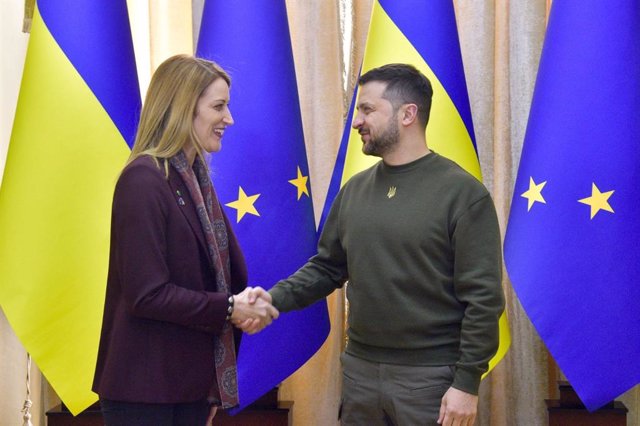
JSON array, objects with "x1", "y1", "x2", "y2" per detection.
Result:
[{"x1": 505, "y1": 0, "x2": 640, "y2": 410}]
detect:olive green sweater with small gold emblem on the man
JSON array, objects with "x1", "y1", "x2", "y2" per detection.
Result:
[{"x1": 270, "y1": 153, "x2": 504, "y2": 394}]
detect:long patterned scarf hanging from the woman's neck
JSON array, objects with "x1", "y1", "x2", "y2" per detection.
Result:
[{"x1": 169, "y1": 151, "x2": 238, "y2": 409}]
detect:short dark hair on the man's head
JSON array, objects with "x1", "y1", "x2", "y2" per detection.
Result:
[{"x1": 358, "y1": 64, "x2": 433, "y2": 127}]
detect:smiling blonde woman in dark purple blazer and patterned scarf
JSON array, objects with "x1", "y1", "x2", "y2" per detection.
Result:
[{"x1": 93, "y1": 55, "x2": 278, "y2": 426}]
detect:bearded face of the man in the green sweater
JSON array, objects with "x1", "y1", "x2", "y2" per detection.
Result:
[{"x1": 352, "y1": 81, "x2": 399, "y2": 157}]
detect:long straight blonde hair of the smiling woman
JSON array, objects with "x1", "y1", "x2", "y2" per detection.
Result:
[{"x1": 127, "y1": 55, "x2": 231, "y2": 172}]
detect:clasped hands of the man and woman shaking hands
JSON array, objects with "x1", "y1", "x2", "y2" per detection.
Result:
[{"x1": 231, "y1": 287, "x2": 280, "y2": 334}]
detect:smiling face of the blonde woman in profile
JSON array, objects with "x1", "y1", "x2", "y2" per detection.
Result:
[{"x1": 193, "y1": 78, "x2": 238, "y2": 153}]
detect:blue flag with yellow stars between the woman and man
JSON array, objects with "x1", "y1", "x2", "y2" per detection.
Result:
[{"x1": 197, "y1": 0, "x2": 329, "y2": 408}]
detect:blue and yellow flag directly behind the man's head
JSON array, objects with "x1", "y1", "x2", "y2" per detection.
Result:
[{"x1": 321, "y1": 0, "x2": 511, "y2": 369}]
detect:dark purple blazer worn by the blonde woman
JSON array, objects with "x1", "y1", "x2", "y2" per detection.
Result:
[{"x1": 93, "y1": 156, "x2": 247, "y2": 403}]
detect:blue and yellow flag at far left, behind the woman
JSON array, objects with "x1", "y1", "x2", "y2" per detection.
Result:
[{"x1": 0, "y1": 0, "x2": 140, "y2": 414}]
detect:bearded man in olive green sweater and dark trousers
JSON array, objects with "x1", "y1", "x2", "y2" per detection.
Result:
[{"x1": 252, "y1": 64, "x2": 504, "y2": 426}]
